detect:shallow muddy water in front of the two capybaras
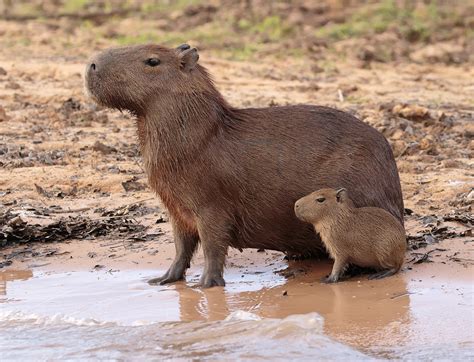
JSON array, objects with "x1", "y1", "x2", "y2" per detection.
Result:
[{"x1": 0, "y1": 240, "x2": 474, "y2": 360}]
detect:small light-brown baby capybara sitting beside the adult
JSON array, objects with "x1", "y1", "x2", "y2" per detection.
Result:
[{"x1": 295, "y1": 188, "x2": 407, "y2": 283}]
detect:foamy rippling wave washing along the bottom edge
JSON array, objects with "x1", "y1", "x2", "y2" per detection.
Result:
[{"x1": 0, "y1": 311, "x2": 367, "y2": 360}]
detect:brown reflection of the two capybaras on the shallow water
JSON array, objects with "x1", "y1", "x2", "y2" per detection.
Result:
[{"x1": 175, "y1": 262, "x2": 410, "y2": 348}]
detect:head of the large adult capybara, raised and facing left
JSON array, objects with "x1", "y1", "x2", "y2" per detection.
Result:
[{"x1": 85, "y1": 44, "x2": 205, "y2": 114}]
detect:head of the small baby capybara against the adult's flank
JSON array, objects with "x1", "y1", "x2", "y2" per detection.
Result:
[{"x1": 295, "y1": 188, "x2": 352, "y2": 224}]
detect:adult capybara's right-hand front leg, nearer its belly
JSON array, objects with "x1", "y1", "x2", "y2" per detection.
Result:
[{"x1": 199, "y1": 218, "x2": 229, "y2": 288}]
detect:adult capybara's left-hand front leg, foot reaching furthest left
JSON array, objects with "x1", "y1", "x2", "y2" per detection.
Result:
[{"x1": 148, "y1": 222, "x2": 199, "y2": 285}]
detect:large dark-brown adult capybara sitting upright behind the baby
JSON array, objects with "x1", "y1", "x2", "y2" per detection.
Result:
[{"x1": 86, "y1": 44, "x2": 403, "y2": 287}]
